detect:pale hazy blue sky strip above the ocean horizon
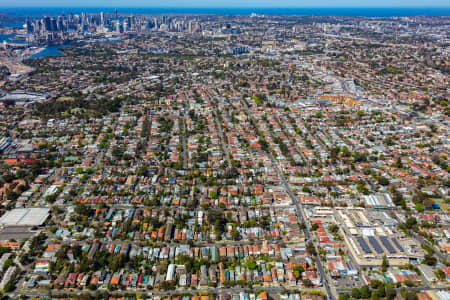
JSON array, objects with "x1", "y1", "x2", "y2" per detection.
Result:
[{"x1": 0, "y1": 0, "x2": 450, "y2": 8}]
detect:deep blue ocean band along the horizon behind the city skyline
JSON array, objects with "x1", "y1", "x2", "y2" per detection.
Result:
[{"x1": 0, "y1": 7, "x2": 450, "y2": 17}]
